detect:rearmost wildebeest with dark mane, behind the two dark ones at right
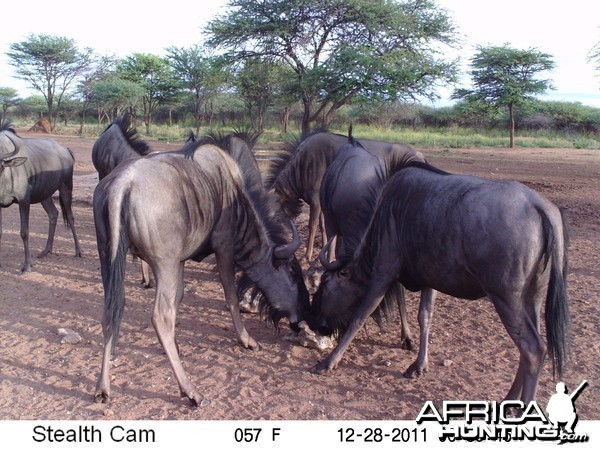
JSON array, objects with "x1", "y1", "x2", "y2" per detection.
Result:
[{"x1": 266, "y1": 131, "x2": 424, "y2": 261}]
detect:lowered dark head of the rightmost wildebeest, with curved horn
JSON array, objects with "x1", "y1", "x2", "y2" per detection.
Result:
[{"x1": 308, "y1": 241, "x2": 367, "y2": 336}]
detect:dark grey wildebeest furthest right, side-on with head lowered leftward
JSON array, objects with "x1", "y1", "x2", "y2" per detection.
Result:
[{"x1": 310, "y1": 159, "x2": 569, "y2": 403}]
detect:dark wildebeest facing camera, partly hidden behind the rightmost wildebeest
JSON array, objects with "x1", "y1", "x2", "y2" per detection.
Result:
[{"x1": 319, "y1": 135, "x2": 413, "y2": 350}]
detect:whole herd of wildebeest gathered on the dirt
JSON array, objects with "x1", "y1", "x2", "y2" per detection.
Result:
[{"x1": 0, "y1": 117, "x2": 569, "y2": 406}]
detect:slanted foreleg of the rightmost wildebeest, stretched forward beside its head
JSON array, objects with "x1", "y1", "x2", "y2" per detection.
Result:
[{"x1": 312, "y1": 284, "x2": 387, "y2": 373}]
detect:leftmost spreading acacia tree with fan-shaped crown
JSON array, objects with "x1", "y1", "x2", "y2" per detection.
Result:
[{"x1": 6, "y1": 34, "x2": 93, "y2": 129}]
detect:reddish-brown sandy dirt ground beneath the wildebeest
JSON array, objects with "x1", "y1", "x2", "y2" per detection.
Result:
[{"x1": 0, "y1": 133, "x2": 600, "y2": 420}]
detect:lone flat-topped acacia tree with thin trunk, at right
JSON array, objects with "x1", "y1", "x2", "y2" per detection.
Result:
[{"x1": 452, "y1": 44, "x2": 554, "y2": 148}]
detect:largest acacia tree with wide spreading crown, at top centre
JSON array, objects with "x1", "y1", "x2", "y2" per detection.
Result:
[{"x1": 206, "y1": 0, "x2": 455, "y2": 132}]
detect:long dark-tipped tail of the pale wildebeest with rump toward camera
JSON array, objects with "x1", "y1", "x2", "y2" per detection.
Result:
[{"x1": 103, "y1": 188, "x2": 128, "y2": 346}]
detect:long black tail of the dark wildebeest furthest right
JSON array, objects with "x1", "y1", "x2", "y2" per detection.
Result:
[{"x1": 540, "y1": 210, "x2": 570, "y2": 379}]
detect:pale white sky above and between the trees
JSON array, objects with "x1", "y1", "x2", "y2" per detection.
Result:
[{"x1": 0, "y1": 0, "x2": 600, "y2": 107}]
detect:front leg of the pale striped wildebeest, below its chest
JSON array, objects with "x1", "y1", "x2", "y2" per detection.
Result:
[{"x1": 215, "y1": 249, "x2": 260, "y2": 350}]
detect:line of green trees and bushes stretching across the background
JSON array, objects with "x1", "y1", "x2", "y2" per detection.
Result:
[{"x1": 0, "y1": 0, "x2": 599, "y2": 145}]
